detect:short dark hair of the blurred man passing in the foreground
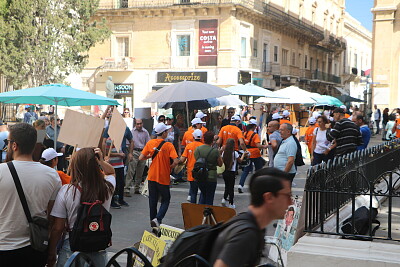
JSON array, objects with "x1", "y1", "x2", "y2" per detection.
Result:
[{"x1": 249, "y1": 168, "x2": 291, "y2": 207}]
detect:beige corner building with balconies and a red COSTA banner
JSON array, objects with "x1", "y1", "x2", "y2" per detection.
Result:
[{"x1": 79, "y1": 0, "x2": 346, "y2": 111}]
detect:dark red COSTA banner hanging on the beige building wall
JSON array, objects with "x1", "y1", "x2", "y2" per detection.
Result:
[{"x1": 199, "y1": 19, "x2": 218, "y2": 66}]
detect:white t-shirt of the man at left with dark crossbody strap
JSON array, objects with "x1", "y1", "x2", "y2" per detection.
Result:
[{"x1": 0, "y1": 160, "x2": 61, "y2": 250}]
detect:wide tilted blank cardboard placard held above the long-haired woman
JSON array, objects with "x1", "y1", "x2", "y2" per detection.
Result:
[{"x1": 58, "y1": 109, "x2": 104, "y2": 148}]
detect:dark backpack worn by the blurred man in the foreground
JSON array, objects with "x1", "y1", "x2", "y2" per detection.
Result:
[{"x1": 160, "y1": 214, "x2": 262, "y2": 267}]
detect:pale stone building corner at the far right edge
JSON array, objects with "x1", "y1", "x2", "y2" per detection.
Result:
[{"x1": 372, "y1": 0, "x2": 400, "y2": 109}]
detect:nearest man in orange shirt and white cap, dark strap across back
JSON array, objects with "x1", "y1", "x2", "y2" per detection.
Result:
[{"x1": 139, "y1": 122, "x2": 179, "y2": 227}]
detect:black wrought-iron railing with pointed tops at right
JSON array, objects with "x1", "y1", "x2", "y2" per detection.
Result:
[{"x1": 304, "y1": 139, "x2": 400, "y2": 241}]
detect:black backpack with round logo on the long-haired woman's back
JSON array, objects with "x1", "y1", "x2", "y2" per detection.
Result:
[{"x1": 69, "y1": 200, "x2": 112, "y2": 252}]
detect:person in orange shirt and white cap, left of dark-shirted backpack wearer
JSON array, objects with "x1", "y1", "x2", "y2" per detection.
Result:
[{"x1": 180, "y1": 129, "x2": 203, "y2": 204}]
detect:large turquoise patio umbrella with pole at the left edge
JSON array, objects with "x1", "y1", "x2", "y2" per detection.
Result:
[{"x1": 0, "y1": 84, "x2": 119, "y2": 148}]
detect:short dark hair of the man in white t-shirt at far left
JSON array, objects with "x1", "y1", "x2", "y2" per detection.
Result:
[{"x1": 9, "y1": 123, "x2": 37, "y2": 155}]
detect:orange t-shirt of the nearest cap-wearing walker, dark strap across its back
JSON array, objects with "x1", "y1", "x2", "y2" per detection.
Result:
[{"x1": 142, "y1": 139, "x2": 178, "y2": 185}]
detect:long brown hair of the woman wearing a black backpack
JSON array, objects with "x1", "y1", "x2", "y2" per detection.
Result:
[{"x1": 68, "y1": 147, "x2": 114, "y2": 203}]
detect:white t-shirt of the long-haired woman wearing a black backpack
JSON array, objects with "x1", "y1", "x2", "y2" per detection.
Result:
[{"x1": 50, "y1": 175, "x2": 115, "y2": 238}]
